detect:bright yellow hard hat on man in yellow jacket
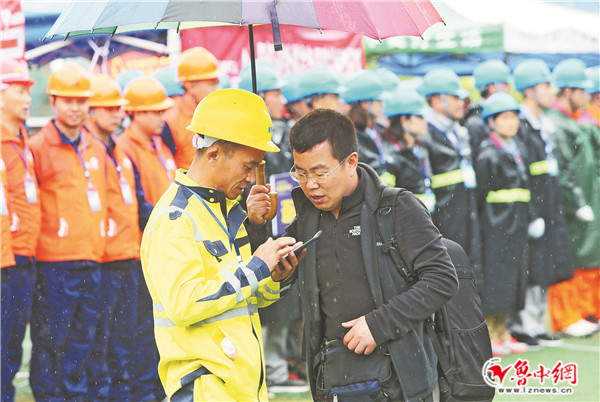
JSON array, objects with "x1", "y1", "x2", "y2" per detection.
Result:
[{"x1": 187, "y1": 88, "x2": 279, "y2": 152}]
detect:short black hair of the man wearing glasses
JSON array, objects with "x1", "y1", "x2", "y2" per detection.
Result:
[{"x1": 290, "y1": 109, "x2": 358, "y2": 161}]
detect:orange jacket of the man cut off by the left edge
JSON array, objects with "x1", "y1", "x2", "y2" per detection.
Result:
[{"x1": 0, "y1": 125, "x2": 41, "y2": 257}]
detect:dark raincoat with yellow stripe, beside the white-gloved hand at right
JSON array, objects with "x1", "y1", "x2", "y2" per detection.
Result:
[{"x1": 518, "y1": 109, "x2": 574, "y2": 287}]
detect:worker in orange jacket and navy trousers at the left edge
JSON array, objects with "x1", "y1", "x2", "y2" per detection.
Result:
[{"x1": 0, "y1": 59, "x2": 40, "y2": 400}]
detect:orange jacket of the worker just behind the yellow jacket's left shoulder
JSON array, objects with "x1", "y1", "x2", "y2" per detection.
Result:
[{"x1": 117, "y1": 126, "x2": 176, "y2": 205}]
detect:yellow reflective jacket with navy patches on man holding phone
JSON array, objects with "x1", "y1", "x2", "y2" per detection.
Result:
[{"x1": 141, "y1": 170, "x2": 280, "y2": 401}]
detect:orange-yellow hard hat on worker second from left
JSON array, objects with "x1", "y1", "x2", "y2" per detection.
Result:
[{"x1": 46, "y1": 62, "x2": 93, "y2": 98}]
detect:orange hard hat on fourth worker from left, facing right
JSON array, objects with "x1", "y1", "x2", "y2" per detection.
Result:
[{"x1": 125, "y1": 76, "x2": 175, "y2": 112}]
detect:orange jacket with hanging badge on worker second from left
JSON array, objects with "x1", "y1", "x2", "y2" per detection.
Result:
[{"x1": 29, "y1": 121, "x2": 107, "y2": 262}]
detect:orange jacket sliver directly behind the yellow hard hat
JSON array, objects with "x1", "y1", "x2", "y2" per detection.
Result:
[{"x1": 164, "y1": 96, "x2": 196, "y2": 170}]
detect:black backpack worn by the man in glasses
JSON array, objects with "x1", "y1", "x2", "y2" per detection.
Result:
[{"x1": 376, "y1": 187, "x2": 495, "y2": 401}]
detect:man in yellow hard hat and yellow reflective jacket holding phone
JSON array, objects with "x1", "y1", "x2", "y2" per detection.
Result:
[{"x1": 141, "y1": 89, "x2": 298, "y2": 401}]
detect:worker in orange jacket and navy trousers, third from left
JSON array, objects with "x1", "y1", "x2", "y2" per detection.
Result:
[{"x1": 85, "y1": 74, "x2": 141, "y2": 400}]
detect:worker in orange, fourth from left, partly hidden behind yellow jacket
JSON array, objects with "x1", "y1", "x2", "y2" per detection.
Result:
[{"x1": 117, "y1": 76, "x2": 175, "y2": 401}]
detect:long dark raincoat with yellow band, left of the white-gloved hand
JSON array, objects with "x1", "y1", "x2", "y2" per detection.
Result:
[{"x1": 475, "y1": 136, "x2": 534, "y2": 314}]
